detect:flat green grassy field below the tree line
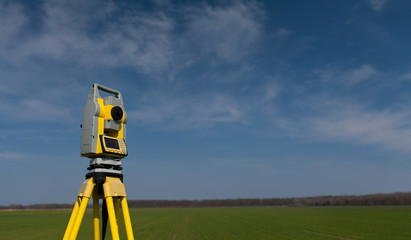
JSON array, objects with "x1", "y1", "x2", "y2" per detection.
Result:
[{"x1": 0, "y1": 207, "x2": 411, "y2": 240}]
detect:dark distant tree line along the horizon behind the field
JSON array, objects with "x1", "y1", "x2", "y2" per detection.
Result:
[{"x1": 0, "y1": 192, "x2": 411, "y2": 210}]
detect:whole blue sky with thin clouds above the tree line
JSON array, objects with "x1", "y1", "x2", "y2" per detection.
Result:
[{"x1": 0, "y1": 0, "x2": 411, "y2": 205}]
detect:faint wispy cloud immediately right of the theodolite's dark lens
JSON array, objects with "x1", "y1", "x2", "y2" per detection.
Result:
[{"x1": 128, "y1": 93, "x2": 247, "y2": 129}]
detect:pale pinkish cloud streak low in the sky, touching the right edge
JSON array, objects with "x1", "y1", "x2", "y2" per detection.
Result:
[{"x1": 305, "y1": 103, "x2": 411, "y2": 152}]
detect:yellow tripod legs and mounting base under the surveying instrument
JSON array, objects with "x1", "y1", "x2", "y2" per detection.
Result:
[{"x1": 63, "y1": 158, "x2": 134, "y2": 240}]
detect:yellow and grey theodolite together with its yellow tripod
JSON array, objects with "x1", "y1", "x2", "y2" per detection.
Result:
[{"x1": 63, "y1": 83, "x2": 134, "y2": 240}]
